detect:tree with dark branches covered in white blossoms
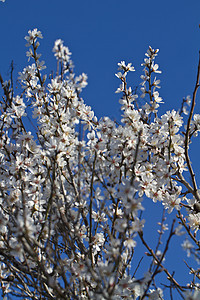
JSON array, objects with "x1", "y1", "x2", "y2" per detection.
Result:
[{"x1": 0, "y1": 29, "x2": 200, "y2": 300}]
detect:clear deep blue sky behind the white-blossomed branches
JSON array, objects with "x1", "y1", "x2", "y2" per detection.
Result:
[{"x1": 0, "y1": 0, "x2": 200, "y2": 298}]
